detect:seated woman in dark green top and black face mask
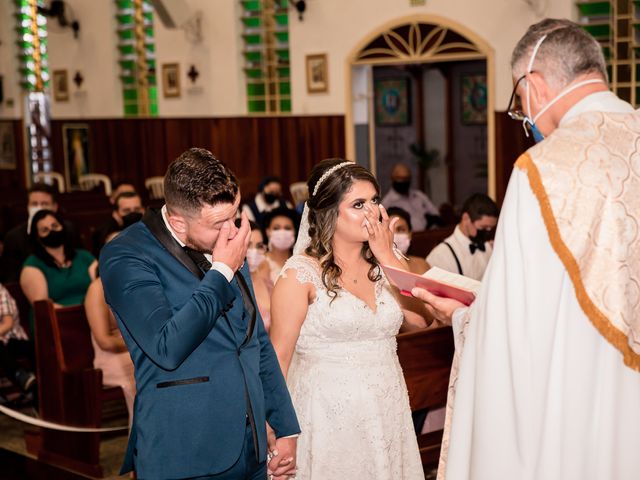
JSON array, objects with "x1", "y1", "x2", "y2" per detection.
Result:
[{"x1": 20, "y1": 210, "x2": 98, "y2": 307}]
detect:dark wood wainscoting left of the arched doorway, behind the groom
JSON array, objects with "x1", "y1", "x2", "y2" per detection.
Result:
[{"x1": 46, "y1": 115, "x2": 345, "y2": 198}]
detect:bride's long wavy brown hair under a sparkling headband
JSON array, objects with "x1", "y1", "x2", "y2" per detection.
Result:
[{"x1": 305, "y1": 158, "x2": 381, "y2": 299}]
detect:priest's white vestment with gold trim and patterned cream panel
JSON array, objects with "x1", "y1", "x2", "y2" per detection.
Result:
[{"x1": 438, "y1": 92, "x2": 640, "y2": 480}]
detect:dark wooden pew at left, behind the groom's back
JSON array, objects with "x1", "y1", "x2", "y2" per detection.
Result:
[{"x1": 27, "y1": 300, "x2": 126, "y2": 477}]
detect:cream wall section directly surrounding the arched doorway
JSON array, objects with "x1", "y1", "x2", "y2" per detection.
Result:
[{"x1": 289, "y1": 0, "x2": 574, "y2": 114}]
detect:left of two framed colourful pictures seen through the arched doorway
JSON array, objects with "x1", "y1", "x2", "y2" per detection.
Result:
[{"x1": 375, "y1": 78, "x2": 411, "y2": 126}]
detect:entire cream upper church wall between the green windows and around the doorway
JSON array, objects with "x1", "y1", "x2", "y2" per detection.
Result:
[{"x1": 0, "y1": 0, "x2": 574, "y2": 118}]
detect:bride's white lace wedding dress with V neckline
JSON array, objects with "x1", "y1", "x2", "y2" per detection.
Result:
[{"x1": 281, "y1": 255, "x2": 424, "y2": 480}]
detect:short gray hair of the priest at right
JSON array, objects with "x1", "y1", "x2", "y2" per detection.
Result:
[{"x1": 511, "y1": 18, "x2": 607, "y2": 89}]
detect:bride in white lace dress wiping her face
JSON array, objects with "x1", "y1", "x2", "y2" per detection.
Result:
[{"x1": 270, "y1": 159, "x2": 426, "y2": 480}]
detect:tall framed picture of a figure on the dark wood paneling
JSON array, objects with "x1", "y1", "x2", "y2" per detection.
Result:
[{"x1": 62, "y1": 123, "x2": 91, "y2": 190}]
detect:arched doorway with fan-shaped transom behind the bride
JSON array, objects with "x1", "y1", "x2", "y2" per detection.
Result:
[{"x1": 345, "y1": 15, "x2": 496, "y2": 203}]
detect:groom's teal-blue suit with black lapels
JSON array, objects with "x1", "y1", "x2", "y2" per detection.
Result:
[{"x1": 100, "y1": 211, "x2": 300, "y2": 479}]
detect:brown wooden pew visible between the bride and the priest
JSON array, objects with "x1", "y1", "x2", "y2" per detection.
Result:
[{"x1": 397, "y1": 327, "x2": 454, "y2": 473}]
